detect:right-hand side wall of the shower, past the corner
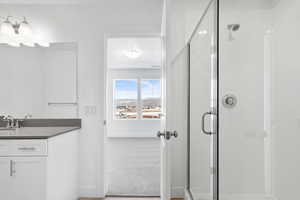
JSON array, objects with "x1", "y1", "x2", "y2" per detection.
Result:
[{"x1": 272, "y1": 0, "x2": 300, "y2": 200}]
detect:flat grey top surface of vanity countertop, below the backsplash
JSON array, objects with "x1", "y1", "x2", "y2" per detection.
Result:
[{"x1": 0, "y1": 126, "x2": 80, "y2": 139}]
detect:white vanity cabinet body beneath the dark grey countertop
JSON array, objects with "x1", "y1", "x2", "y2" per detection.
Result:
[{"x1": 0, "y1": 131, "x2": 78, "y2": 200}]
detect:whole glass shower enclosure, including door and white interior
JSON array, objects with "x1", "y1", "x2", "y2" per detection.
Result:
[{"x1": 188, "y1": 0, "x2": 300, "y2": 200}]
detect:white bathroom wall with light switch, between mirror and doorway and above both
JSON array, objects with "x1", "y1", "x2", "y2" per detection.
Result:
[{"x1": 0, "y1": 0, "x2": 162, "y2": 197}]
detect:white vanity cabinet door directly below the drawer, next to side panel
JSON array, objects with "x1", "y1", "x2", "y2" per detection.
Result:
[{"x1": 10, "y1": 157, "x2": 46, "y2": 200}]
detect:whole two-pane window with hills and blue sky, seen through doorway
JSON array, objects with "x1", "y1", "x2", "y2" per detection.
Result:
[{"x1": 114, "y1": 79, "x2": 161, "y2": 120}]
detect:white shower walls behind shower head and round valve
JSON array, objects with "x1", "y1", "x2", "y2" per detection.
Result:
[{"x1": 220, "y1": 0, "x2": 300, "y2": 200}]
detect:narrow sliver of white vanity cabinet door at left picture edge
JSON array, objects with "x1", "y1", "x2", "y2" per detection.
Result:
[{"x1": 0, "y1": 157, "x2": 12, "y2": 200}]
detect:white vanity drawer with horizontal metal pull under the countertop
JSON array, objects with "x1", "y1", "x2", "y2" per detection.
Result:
[{"x1": 0, "y1": 140, "x2": 47, "y2": 156}]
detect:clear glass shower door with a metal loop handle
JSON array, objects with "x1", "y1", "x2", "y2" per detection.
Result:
[{"x1": 189, "y1": 1, "x2": 218, "y2": 200}]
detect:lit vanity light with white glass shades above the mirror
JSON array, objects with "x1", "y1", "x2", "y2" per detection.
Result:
[{"x1": 0, "y1": 16, "x2": 50, "y2": 47}]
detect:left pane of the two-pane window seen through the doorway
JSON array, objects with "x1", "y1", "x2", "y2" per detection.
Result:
[{"x1": 114, "y1": 80, "x2": 138, "y2": 119}]
